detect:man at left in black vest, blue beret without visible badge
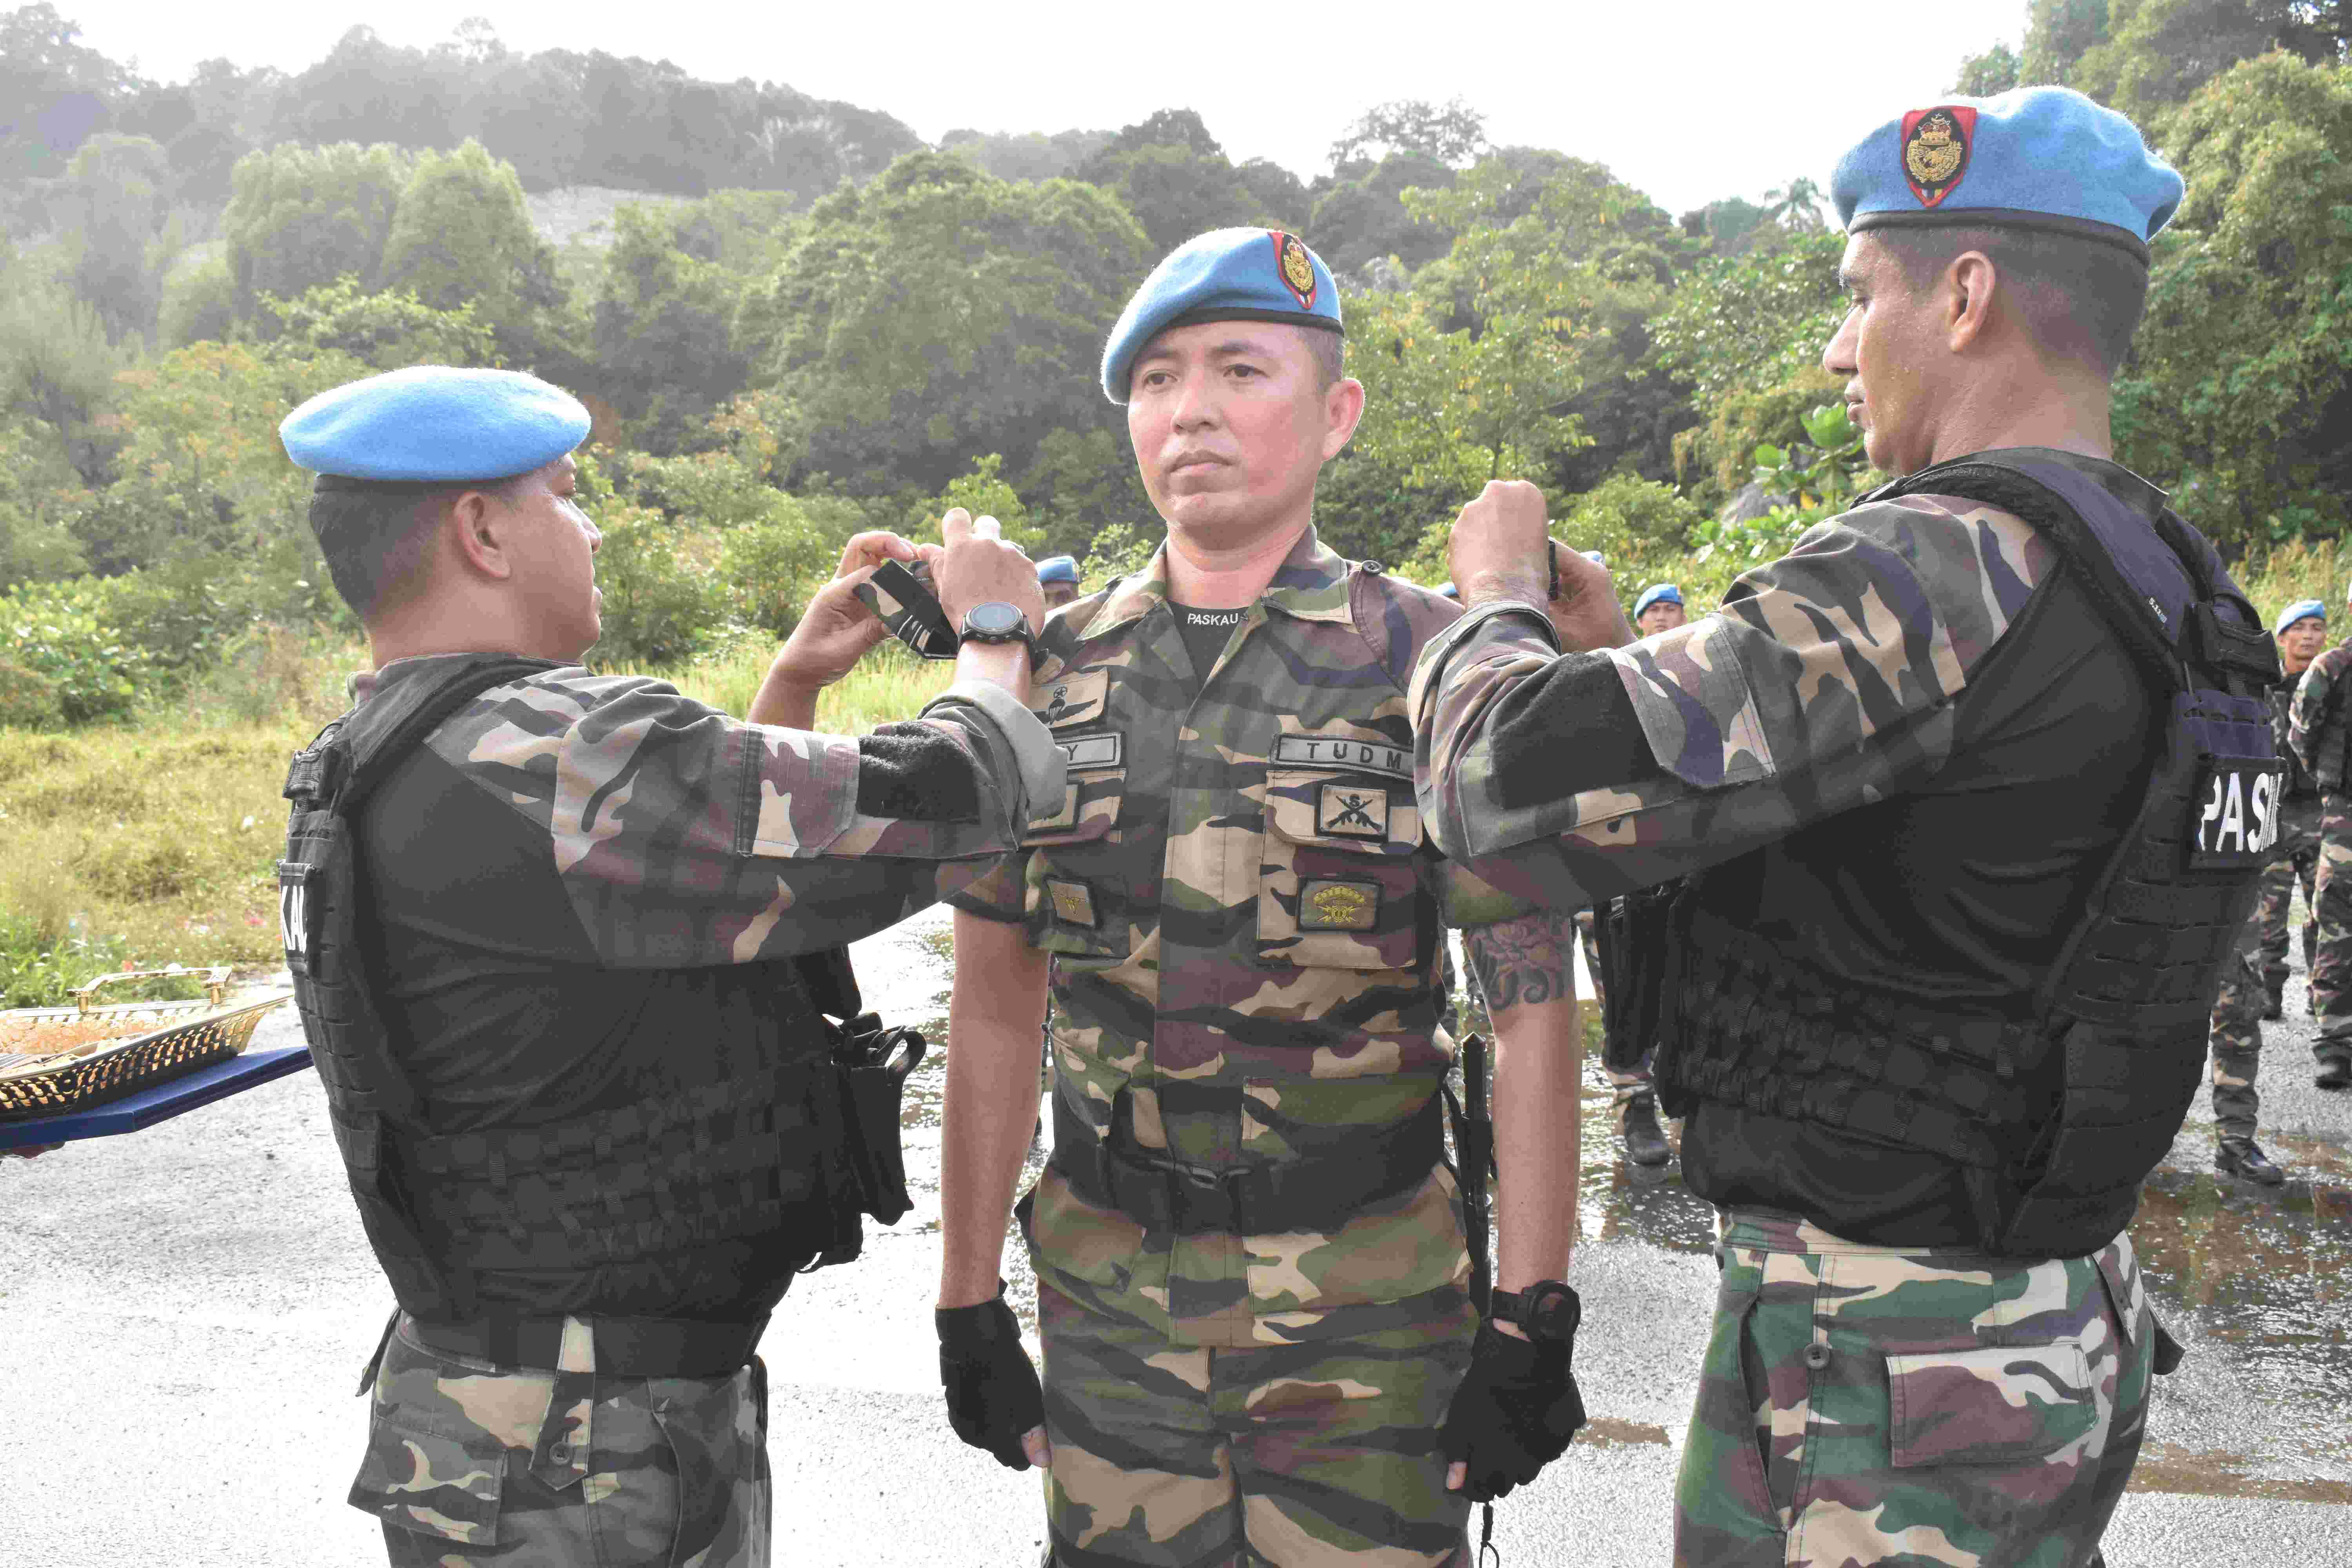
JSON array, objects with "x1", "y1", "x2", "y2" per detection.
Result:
[{"x1": 280, "y1": 367, "x2": 1063, "y2": 1568}]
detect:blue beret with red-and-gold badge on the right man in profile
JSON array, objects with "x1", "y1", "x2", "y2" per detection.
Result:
[{"x1": 1830, "y1": 87, "x2": 2183, "y2": 261}]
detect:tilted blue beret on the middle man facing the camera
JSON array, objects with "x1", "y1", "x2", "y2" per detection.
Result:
[{"x1": 1103, "y1": 228, "x2": 1341, "y2": 402}]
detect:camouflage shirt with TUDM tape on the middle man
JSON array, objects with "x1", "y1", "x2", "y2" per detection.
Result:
[{"x1": 950, "y1": 531, "x2": 1526, "y2": 1345}]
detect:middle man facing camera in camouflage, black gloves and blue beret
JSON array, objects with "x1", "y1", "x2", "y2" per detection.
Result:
[{"x1": 938, "y1": 228, "x2": 1583, "y2": 1568}]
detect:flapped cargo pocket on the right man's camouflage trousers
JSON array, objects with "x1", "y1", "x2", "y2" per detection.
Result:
[{"x1": 1886, "y1": 1340, "x2": 2098, "y2": 1469}]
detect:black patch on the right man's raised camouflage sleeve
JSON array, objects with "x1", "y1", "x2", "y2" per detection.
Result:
[{"x1": 1486, "y1": 653, "x2": 1665, "y2": 809}]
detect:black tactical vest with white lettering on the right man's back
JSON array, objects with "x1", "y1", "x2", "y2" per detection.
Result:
[{"x1": 1656, "y1": 454, "x2": 2286, "y2": 1258}]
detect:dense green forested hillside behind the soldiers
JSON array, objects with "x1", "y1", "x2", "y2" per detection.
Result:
[{"x1": 0, "y1": 0, "x2": 2352, "y2": 726}]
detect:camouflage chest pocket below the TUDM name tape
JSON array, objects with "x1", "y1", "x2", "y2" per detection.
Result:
[{"x1": 1258, "y1": 769, "x2": 1421, "y2": 969}]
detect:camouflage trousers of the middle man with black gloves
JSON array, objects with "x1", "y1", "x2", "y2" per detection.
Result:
[{"x1": 1037, "y1": 1283, "x2": 1477, "y2": 1568}]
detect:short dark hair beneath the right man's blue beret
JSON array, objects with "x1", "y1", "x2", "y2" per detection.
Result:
[{"x1": 1870, "y1": 226, "x2": 2147, "y2": 381}]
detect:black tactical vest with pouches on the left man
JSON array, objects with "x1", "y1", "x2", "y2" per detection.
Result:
[{"x1": 278, "y1": 656, "x2": 858, "y2": 1323}]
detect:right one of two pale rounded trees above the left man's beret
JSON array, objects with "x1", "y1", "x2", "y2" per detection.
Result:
[{"x1": 381, "y1": 141, "x2": 562, "y2": 362}]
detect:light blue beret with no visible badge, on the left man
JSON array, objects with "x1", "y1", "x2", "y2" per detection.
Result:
[{"x1": 278, "y1": 365, "x2": 588, "y2": 484}]
